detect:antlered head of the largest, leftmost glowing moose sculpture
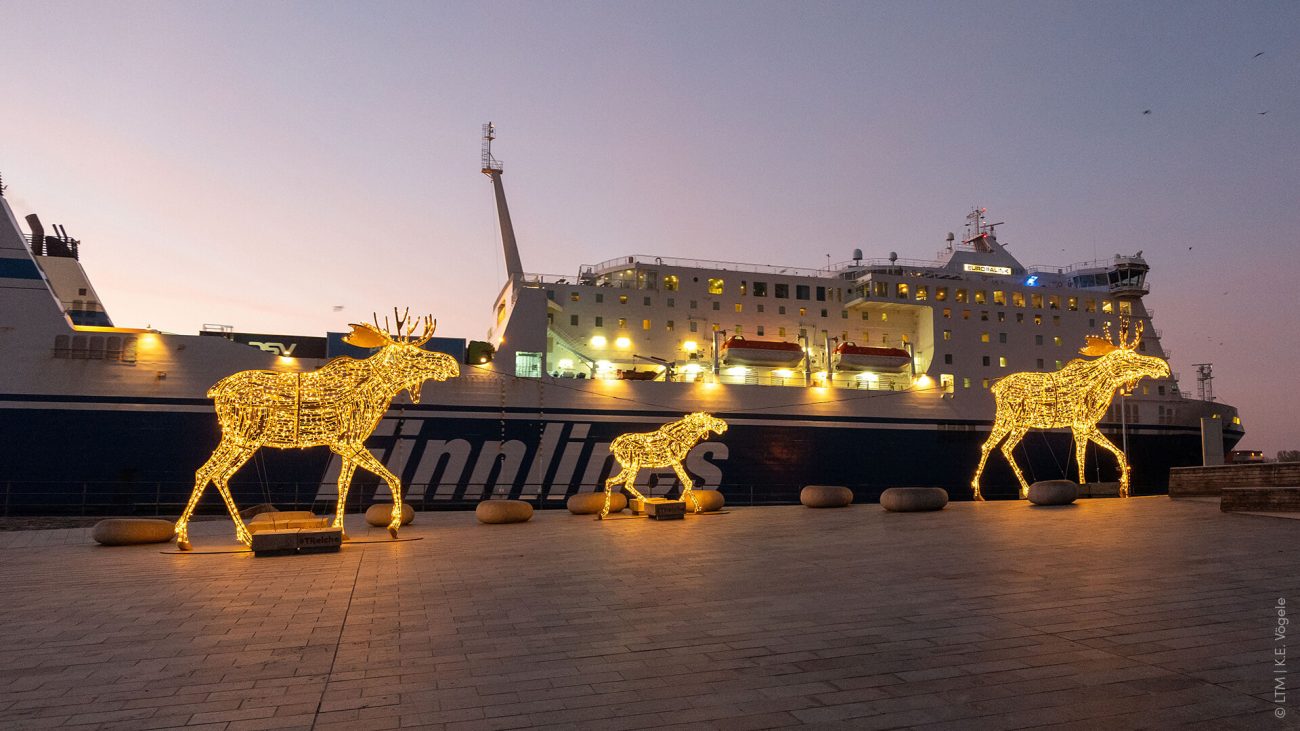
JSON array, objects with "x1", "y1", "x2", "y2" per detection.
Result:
[{"x1": 343, "y1": 308, "x2": 460, "y2": 403}]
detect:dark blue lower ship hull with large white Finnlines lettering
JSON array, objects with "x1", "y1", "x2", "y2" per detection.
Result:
[{"x1": 0, "y1": 397, "x2": 1240, "y2": 515}]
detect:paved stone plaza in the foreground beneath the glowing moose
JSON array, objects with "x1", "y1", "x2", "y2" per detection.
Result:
[{"x1": 0, "y1": 497, "x2": 1300, "y2": 731}]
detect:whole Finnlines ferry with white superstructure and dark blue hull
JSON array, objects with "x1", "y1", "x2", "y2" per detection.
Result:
[{"x1": 0, "y1": 125, "x2": 1244, "y2": 515}]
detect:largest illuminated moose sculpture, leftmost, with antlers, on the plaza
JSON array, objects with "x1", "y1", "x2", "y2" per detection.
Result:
[{"x1": 176, "y1": 311, "x2": 460, "y2": 550}]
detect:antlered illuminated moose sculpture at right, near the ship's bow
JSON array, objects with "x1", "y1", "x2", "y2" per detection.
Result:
[{"x1": 971, "y1": 320, "x2": 1169, "y2": 499}]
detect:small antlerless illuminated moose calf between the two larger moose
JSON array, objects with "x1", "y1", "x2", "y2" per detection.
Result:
[{"x1": 597, "y1": 411, "x2": 727, "y2": 519}]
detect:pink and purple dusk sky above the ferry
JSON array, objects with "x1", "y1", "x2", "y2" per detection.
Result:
[{"x1": 0, "y1": 0, "x2": 1300, "y2": 457}]
